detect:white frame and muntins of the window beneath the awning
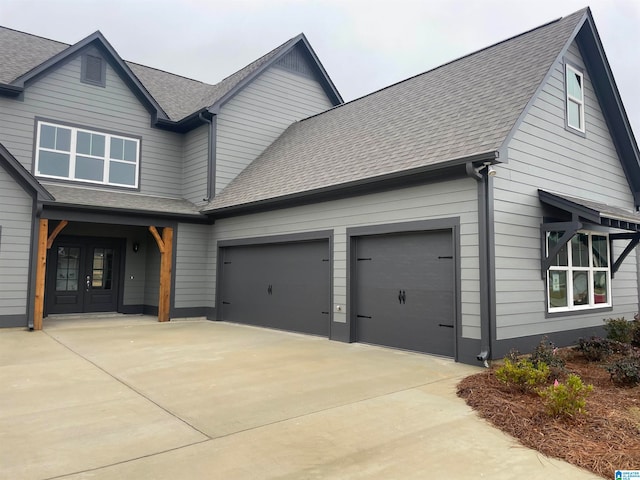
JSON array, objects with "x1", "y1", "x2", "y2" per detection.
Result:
[{"x1": 546, "y1": 230, "x2": 613, "y2": 313}]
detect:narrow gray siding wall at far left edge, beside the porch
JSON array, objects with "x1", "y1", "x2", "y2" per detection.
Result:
[{"x1": 0, "y1": 166, "x2": 33, "y2": 318}]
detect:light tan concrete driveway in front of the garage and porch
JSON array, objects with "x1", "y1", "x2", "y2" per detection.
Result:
[{"x1": 0, "y1": 316, "x2": 599, "y2": 480}]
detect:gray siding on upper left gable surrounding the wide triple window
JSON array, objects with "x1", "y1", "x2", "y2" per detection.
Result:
[{"x1": 0, "y1": 57, "x2": 182, "y2": 197}]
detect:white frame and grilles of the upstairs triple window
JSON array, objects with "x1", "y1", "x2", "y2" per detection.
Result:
[{"x1": 35, "y1": 121, "x2": 140, "y2": 189}]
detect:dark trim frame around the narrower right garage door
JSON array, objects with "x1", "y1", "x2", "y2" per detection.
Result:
[{"x1": 348, "y1": 217, "x2": 462, "y2": 363}]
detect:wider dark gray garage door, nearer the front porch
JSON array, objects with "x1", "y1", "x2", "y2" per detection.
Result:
[{"x1": 220, "y1": 240, "x2": 331, "y2": 336}]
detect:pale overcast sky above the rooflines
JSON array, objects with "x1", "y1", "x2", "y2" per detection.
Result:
[{"x1": 0, "y1": 0, "x2": 640, "y2": 138}]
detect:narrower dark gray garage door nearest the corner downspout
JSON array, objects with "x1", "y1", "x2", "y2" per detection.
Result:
[{"x1": 355, "y1": 230, "x2": 455, "y2": 356}]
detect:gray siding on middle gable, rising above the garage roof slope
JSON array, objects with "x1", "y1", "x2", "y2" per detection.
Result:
[{"x1": 216, "y1": 67, "x2": 332, "y2": 192}]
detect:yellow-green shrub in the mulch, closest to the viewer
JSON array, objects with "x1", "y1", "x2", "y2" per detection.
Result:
[{"x1": 538, "y1": 373, "x2": 593, "y2": 417}]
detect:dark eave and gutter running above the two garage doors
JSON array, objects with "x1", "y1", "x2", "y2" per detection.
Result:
[{"x1": 202, "y1": 150, "x2": 499, "y2": 219}]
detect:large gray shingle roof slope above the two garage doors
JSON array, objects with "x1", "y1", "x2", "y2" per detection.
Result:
[{"x1": 204, "y1": 9, "x2": 587, "y2": 212}]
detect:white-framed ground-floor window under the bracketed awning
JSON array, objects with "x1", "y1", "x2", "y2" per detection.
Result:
[{"x1": 546, "y1": 232, "x2": 612, "y2": 313}]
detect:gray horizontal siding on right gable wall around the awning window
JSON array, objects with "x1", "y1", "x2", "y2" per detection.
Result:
[{"x1": 494, "y1": 40, "x2": 638, "y2": 339}]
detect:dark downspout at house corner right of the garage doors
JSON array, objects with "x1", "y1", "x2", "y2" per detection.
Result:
[{"x1": 466, "y1": 162, "x2": 495, "y2": 367}]
